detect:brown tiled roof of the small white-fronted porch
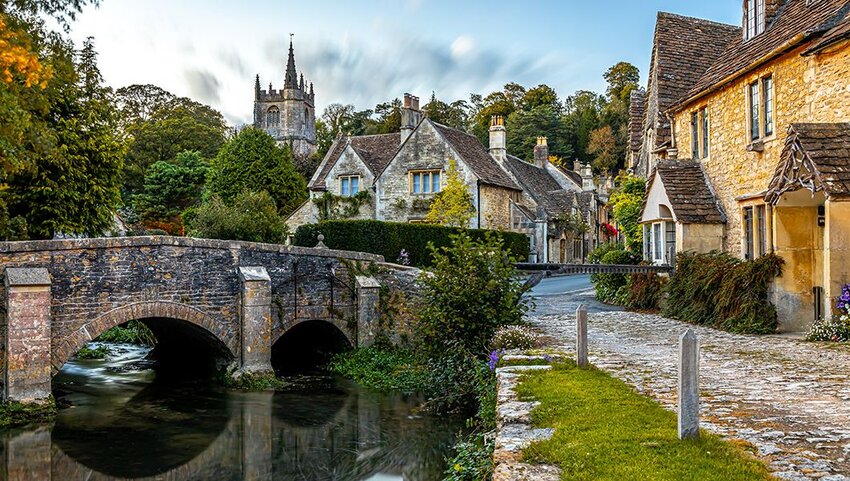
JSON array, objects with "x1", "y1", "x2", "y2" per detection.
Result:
[{"x1": 643, "y1": 160, "x2": 726, "y2": 224}]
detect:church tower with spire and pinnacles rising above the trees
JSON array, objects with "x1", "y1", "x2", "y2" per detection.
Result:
[{"x1": 254, "y1": 36, "x2": 316, "y2": 157}]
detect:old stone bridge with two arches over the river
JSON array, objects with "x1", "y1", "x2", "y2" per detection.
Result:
[{"x1": 0, "y1": 237, "x2": 383, "y2": 401}]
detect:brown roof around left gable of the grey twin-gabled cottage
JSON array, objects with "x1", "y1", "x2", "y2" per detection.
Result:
[{"x1": 308, "y1": 133, "x2": 401, "y2": 190}]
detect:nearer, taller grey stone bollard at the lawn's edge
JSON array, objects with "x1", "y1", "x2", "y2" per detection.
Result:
[{"x1": 679, "y1": 329, "x2": 699, "y2": 439}]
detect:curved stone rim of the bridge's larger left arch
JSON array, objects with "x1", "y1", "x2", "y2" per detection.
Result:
[{"x1": 51, "y1": 301, "x2": 239, "y2": 375}]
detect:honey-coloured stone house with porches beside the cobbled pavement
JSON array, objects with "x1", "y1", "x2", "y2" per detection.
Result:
[{"x1": 632, "y1": 0, "x2": 850, "y2": 331}]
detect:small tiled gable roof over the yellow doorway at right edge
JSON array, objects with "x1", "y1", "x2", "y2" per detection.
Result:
[{"x1": 765, "y1": 123, "x2": 850, "y2": 204}]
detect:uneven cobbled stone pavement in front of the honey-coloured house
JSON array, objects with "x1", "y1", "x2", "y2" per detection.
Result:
[{"x1": 530, "y1": 296, "x2": 850, "y2": 481}]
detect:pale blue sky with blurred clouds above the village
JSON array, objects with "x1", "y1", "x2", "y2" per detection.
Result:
[{"x1": 66, "y1": 0, "x2": 741, "y2": 125}]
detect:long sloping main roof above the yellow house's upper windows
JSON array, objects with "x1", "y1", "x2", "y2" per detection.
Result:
[{"x1": 677, "y1": 0, "x2": 850, "y2": 106}]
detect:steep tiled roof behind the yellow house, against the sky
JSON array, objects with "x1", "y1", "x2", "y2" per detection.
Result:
[{"x1": 648, "y1": 12, "x2": 742, "y2": 147}]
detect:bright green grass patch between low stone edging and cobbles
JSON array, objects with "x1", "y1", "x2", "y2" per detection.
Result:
[{"x1": 518, "y1": 363, "x2": 772, "y2": 481}]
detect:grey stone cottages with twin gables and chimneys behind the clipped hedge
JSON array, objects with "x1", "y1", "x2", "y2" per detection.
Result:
[{"x1": 287, "y1": 94, "x2": 599, "y2": 262}]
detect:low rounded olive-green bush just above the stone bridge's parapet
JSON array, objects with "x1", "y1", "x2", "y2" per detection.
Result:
[{"x1": 187, "y1": 190, "x2": 289, "y2": 244}]
